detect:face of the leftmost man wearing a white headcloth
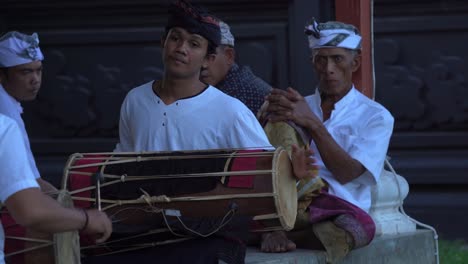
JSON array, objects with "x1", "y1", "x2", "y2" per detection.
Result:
[{"x1": 0, "y1": 61, "x2": 42, "y2": 101}]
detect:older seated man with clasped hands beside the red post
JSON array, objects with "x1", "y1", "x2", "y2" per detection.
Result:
[{"x1": 261, "y1": 17, "x2": 394, "y2": 263}]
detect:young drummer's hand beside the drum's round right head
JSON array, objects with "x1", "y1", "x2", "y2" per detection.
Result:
[{"x1": 291, "y1": 145, "x2": 318, "y2": 179}]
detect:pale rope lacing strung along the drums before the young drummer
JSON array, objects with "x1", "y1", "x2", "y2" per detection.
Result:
[{"x1": 60, "y1": 149, "x2": 288, "y2": 255}]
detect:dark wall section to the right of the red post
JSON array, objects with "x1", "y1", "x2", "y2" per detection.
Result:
[{"x1": 374, "y1": 0, "x2": 468, "y2": 239}]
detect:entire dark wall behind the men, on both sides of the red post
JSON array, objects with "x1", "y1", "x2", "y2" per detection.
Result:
[{"x1": 0, "y1": 0, "x2": 468, "y2": 240}]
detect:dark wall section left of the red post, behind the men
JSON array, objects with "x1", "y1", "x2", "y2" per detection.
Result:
[{"x1": 0, "y1": 0, "x2": 332, "y2": 184}]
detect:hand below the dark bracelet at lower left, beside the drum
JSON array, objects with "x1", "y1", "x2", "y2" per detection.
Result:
[{"x1": 83, "y1": 209, "x2": 112, "y2": 243}]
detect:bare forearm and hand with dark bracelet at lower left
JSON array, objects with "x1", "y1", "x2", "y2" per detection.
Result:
[{"x1": 5, "y1": 188, "x2": 112, "y2": 243}]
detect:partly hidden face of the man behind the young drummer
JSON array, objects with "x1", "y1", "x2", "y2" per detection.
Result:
[{"x1": 200, "y1": 45, "x2": 234, "y2": 85}]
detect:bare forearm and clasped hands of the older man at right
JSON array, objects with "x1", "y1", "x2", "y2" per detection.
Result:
[{"x1": 267, "y1": 88, "x2": 366, "y2": 184}]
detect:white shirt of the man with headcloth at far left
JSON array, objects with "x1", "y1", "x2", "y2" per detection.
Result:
[{"x1": 0, "y1": 84, "x2": 41, "y2": 179}]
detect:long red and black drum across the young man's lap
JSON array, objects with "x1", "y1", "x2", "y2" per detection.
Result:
[{"x1": 62, "y1": 149, "x2": 297, "y2": 230}]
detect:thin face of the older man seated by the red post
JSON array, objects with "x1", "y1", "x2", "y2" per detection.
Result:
[{"x1": 312, "y1": 48, "x2": 361, "y2": 97}]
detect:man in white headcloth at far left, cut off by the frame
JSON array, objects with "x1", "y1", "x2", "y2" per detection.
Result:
[{"x1": 0, "y1": 31, "x2": 57, "y2": 193}]
